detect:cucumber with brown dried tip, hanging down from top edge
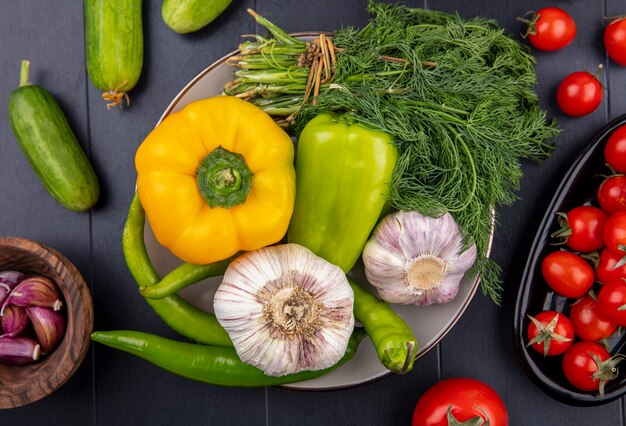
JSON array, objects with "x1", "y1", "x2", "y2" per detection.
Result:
[{"x1": 84, "y1": 0, "x2": 143, "y2": 108}]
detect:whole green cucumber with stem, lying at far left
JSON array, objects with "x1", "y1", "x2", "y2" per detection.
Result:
[{"x1": 9, "y1": 61, "x2": 100, "y2": 211}]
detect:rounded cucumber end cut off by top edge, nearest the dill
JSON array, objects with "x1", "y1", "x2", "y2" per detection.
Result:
[{"x1": 161, "y1": 0, "x2": 232, "y2": 34}]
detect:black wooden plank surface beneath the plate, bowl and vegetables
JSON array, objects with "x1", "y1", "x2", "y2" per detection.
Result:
[{"x1": 0, "y1": 0, "x2": 626, "y2": 426}]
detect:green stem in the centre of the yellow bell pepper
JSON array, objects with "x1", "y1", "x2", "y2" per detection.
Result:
[{"x1": 196, "y1": 146, "x2": 253, "y2": 208}]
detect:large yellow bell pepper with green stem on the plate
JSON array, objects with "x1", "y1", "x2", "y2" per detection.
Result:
[{"x1": 135, "y1": 96, "x2": 295, "y2": 264}]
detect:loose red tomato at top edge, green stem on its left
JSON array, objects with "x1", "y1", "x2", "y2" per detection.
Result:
[{"x1": 527, "y1": 7, "x2": 576, "y2": 51}]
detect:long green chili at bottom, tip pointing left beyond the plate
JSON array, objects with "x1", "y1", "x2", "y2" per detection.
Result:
[{"x1": 91, "y1": 328, "x2": 366, "y2": 387}]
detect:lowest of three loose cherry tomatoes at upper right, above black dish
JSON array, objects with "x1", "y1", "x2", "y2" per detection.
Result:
[{"x1": 556, "y1": 71, "x2": 603, "y2": 117}]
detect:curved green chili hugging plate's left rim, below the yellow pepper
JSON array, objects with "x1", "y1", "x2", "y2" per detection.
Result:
[{"x1": 122, "y1": 194, "x2": 233, "y2": 347}]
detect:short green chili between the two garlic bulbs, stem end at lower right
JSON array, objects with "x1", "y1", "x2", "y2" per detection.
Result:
[{"x1": 348, "y1": 279, "x2": 417, "y2": 374}]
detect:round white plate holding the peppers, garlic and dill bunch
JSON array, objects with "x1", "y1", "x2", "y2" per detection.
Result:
[{"x1": 145, "y1": 34, "x2": 491, "y2": 390}]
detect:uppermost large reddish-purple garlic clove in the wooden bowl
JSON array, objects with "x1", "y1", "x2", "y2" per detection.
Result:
[{"x1": 0, "y1": 277, "x2": 63, "y2": 315}]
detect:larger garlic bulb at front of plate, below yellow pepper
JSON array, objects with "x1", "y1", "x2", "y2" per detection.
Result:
[{"x1": 214, "y1": 244, "x2": 354, "y2": 376}]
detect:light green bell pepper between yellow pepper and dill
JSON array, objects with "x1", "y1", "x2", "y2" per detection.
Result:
[{"x1": 288, "y1": 114, "x2": 398, "y2": 272}]
